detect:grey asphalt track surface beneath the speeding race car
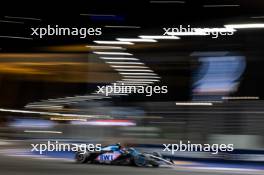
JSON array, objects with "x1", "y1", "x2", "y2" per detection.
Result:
[{"x1": 0, "y1": 155, "x2": 262, "y2": 175}]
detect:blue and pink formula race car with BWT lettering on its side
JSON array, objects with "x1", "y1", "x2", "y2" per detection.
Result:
[{"x1": 75, "y1": 145, "x2": 173, "y2": 167}]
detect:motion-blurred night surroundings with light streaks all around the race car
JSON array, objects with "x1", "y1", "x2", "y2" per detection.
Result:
[{"x1": 0, "y1": 0, "x2": 264, "y2": 174}]
